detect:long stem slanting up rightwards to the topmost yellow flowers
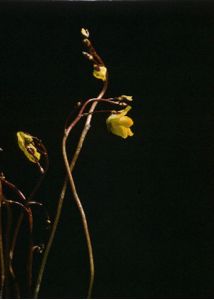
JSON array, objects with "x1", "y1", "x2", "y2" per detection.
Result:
[{"x1": 34, "y1": 80, "x2": 108, "y2": 299}]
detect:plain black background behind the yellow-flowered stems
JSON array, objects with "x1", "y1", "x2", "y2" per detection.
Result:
[{"x1": 0, "y1": 1, "x2": 214, "y2": 298}]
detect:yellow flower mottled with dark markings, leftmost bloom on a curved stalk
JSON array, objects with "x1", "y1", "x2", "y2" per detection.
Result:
[{"x1": 16, "y1": 131, "x2": 41, "y2": 163}]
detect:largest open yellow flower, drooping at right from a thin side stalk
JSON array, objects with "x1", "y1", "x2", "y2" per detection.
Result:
[{"x1": 106, "y1": 106, "x2": 134, "y2": 139}]
